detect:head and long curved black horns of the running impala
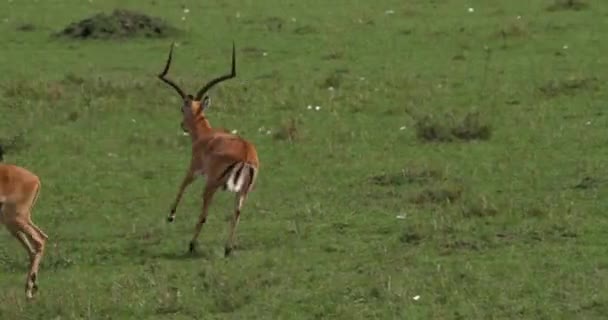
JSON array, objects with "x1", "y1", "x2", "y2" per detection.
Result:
[{"x1": 158, "y1": 43, "x2": 236, "y2": 133}]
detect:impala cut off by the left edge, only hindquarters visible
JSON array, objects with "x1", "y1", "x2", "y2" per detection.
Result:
[{"x1": 0, "y1": 146, "x2": 48, "y2": 299}]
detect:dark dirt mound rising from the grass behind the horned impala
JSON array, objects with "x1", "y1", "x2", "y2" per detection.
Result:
[{"x1": 55, "y1": 9, "x2": 178, "y2": 39}]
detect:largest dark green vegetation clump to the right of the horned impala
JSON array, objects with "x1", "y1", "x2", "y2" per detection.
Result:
[{"x1": 415, "y1": 113, "x2": 492, "y2": 142}]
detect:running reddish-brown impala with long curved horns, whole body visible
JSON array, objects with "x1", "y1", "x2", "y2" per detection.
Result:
[{"x1": 158, "y1": 43, "x2": 260, "y2": 257}]
